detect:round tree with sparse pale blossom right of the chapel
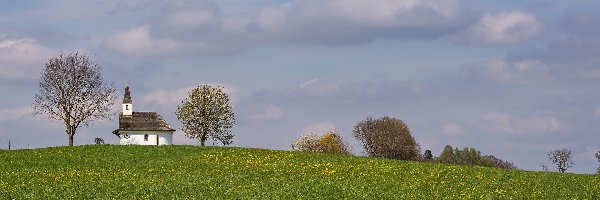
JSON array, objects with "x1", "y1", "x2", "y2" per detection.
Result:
[{"x1": 175, "y1": 85, "x2": 235, "y2": 146}]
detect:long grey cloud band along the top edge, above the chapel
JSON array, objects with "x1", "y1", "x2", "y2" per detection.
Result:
[{"x1": 104, "y1": 0, "x2": 471, "y2": 56}]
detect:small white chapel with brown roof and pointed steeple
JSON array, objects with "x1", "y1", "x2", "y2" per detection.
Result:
[{"x1": 119, "y1": 84, "x2": 175, "y2": 145}]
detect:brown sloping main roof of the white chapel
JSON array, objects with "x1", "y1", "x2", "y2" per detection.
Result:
[{"x1": 119, "y1": 112, "x2": 175, "y2": 131}]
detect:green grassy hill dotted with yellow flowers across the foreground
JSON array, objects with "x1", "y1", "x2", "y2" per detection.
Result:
[{"x1": 0, "y1": 145, "x2": 600, "y2": 199}]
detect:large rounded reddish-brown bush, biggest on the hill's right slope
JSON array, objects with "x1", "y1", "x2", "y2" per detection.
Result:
[{"x1": 354, "y1": 116, "x2": 421, "y2": 160}]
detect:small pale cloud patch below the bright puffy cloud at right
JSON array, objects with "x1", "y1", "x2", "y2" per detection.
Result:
[{"x1": 482, "y1": 60, "x2": 553, "y2": 84}]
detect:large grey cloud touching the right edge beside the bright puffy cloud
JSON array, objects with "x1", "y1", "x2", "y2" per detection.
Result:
[{"x1": 482, "y1": 12, "x2": 600, "y2": 83}]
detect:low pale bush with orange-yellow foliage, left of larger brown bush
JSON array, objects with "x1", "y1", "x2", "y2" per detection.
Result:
[{"x1": 291, "y1": 130, "x2": 351, "y2": 155}]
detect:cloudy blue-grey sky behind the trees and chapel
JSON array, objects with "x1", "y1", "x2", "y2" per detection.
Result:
[{"x1": 0, "y1": 0, "x2": 600, "y2": 173}]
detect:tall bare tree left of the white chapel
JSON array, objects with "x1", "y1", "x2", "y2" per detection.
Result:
[{"x1": 33, "y1": 52, "x2": 116, "y2": 146}]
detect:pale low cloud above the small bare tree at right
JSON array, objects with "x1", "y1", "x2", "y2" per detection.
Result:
[{"x1": 483, "y1": 112, "x2": 569, "y2": 134}]
